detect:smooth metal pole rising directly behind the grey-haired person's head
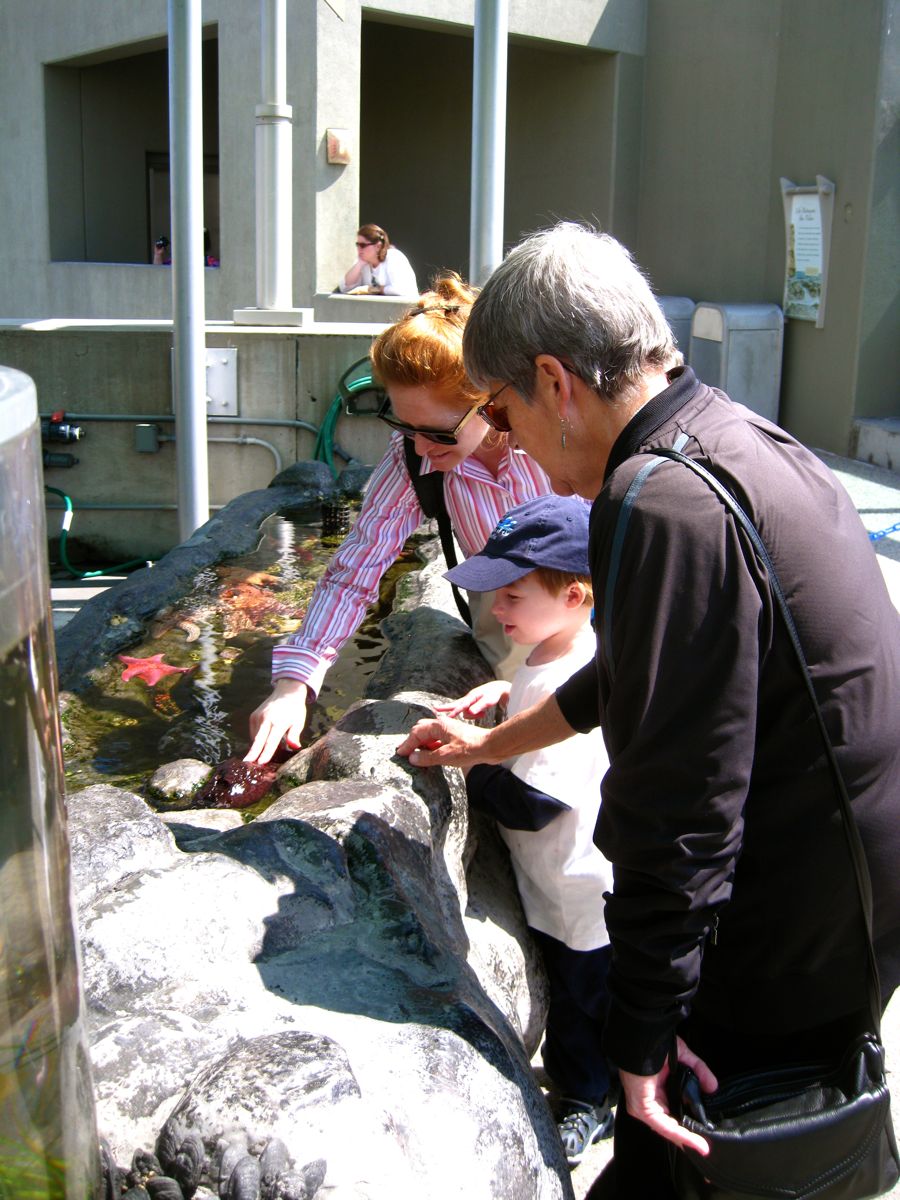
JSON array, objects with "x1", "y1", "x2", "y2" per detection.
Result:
[{"x1": 469, "y1": 0, "x2": 509, "y2": 284}]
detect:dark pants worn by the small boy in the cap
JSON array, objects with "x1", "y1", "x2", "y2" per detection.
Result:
[{"x1": 532, "y1": 929, "x2": 610, "y2": 1104}]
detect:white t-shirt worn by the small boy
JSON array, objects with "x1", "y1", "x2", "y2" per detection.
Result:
[{"x1": 498, "y1": 625, "x2": 612, "y2": 950}]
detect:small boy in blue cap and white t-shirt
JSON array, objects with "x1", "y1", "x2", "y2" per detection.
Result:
[{"x1": 440, "y1": 496, "x2": 613, "y2": 1166}]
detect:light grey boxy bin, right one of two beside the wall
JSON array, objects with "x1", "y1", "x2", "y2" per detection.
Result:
[{"x1": 688, "y1": 301, "x2": 785, "y2": 421}]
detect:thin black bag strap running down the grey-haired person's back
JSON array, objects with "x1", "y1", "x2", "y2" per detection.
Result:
[{"x1": 619, "y1": 438, "x2": 881, "y2": 1036}]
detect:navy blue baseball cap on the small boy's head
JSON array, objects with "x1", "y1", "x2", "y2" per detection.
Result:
[{"x1": 444, "y1": 496, "x2": 590, "y2": 592}]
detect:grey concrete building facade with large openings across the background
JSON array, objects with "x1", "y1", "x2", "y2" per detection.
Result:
[{"x1": 0, "y1": 0, "x2": 900, "y2": 472}]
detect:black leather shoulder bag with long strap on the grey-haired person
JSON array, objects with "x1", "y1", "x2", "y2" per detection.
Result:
[{"x1": 620, "y1": 439, "x2": 900, "y2": 1200}]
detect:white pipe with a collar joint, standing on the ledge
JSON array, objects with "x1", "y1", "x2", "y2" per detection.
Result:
[{"x1": 256, "y1": 0, "x2": 294, "y2": 308}]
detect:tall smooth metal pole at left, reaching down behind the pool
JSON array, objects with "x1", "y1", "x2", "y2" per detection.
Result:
[{"x1": 168, "y1": 0, "x2": 209, "y2": 541}]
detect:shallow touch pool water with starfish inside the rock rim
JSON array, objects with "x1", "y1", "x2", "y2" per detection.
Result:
[{"x1": 62, "y1": 516, "x2": 421, "y2": 791}]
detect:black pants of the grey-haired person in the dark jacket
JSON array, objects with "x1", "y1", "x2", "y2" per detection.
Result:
[{"x1": 588, "y1": 1014, "x2": 866, "y2": 1200}]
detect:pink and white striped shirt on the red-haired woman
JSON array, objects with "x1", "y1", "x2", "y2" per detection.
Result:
[{"x1": 272, "y1": 433, "x2": 552, "y2": 695}]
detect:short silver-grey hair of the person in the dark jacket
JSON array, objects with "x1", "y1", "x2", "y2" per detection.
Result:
[{"x1": 463, "y1": 221, "x2": 676, "y2": 400}]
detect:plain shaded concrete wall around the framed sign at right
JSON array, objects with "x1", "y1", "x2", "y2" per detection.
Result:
[{"x1": 635, "y1": 0, "x2": 900, "y2": 454}]
